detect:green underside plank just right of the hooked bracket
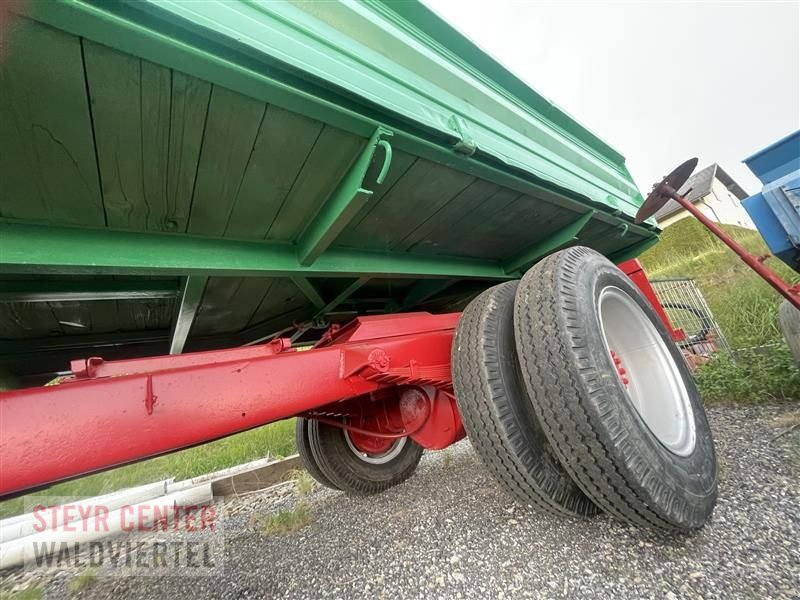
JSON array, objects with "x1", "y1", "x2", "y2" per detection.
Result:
[{"x1": 356, "y1": 160, "x2": 475, "y2": 249}]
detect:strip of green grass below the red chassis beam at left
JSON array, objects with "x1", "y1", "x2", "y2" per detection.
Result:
[{"x1": 0, "y1": 419, "x2": 297, "y2": 518}]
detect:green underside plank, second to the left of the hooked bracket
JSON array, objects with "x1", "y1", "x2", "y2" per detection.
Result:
[{"x1": 225, "y1": 105, "x2": 322, "y2": 239}]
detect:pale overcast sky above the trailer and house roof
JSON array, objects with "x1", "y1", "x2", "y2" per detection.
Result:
[{"x1": 424, "y1": 0, "x2": 800, "y2": 194}]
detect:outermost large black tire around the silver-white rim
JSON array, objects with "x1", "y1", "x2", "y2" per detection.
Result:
[{"x1": 514, "y1": 247, "x2": 717, "y2": 531}]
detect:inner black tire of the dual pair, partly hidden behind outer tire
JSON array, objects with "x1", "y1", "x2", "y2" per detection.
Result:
[{"x1": 451, "y1": 281, "x2": 598, "y2": 516}]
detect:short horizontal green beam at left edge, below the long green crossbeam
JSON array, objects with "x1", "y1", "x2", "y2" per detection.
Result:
[{"x1": 0, "y1": 280, "x2": 179, "y2": 302}]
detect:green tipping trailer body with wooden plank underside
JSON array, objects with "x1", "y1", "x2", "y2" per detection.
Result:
[{"x1": 0, "y1": 0, "x2": 658, "y2": 380}]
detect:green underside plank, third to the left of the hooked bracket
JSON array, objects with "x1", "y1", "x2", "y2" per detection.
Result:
[{"x1": 188, "y1": 87, "x2": 266, "y2": 236}]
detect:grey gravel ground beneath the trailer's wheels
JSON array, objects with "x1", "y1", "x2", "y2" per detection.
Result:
[{"x1": 6, "y1": 407, "x2": 800, "y2": 600}]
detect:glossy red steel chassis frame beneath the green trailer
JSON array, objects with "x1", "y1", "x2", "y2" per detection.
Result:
[{"x1": 0, "y1": 260, "x2": 674, "y2": 497}]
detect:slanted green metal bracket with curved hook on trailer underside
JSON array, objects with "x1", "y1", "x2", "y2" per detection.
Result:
[{"x1": 297, "y1": 127, "x2": 394, "y2": 266}]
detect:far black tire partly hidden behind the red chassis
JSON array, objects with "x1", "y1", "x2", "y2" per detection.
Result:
[{"x1": 308, "y1": 419, "x2": 423, "y2": 496}]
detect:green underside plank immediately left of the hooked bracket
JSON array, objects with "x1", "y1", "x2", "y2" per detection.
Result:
[{"x1": 266, "y1": 125, "x2": 366, "y2": 242}]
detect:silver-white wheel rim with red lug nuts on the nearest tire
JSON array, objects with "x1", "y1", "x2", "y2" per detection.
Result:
[{"x1": 598, "y1": 286, "x2": 695, "y2": 456}]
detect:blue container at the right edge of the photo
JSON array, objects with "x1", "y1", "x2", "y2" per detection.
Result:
[{"x1": 742, "y1": 131, "x2": 800, "y2": 273}]
